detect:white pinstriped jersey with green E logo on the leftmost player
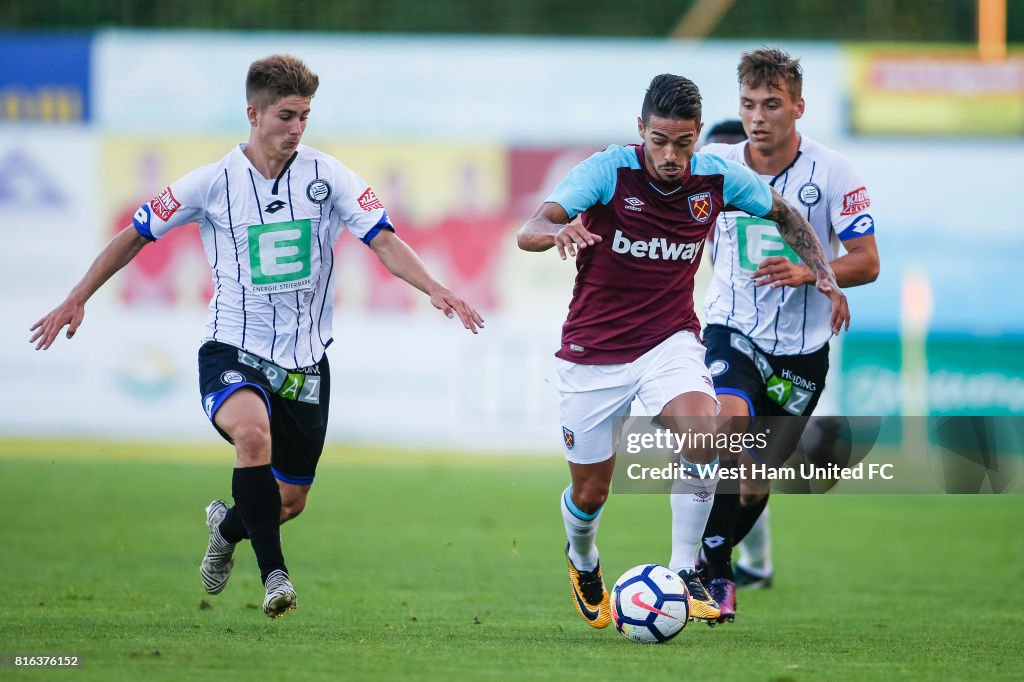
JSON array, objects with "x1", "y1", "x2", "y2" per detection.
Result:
[{"x1": 133, "y1": 144, "x2": 394, "y2": 369}]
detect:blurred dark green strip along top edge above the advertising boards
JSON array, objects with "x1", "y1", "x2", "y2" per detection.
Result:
[{"x1": 0, "y1": 0, "x2": 1024, "y2": 43}]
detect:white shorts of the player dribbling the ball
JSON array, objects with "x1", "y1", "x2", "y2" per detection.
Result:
[{"x1": 555, "y1": 332, "x2": 718, "y2": 464}]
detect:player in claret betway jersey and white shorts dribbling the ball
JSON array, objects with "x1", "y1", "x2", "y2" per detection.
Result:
[{"x1": 518, "y1": 74, "x2": 849, "y2": 628}]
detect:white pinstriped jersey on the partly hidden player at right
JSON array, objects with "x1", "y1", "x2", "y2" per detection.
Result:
[{"x1": 700, "y1": 135, "x2": 874, "y2": 355}]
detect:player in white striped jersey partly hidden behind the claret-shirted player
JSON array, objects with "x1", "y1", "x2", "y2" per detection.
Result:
[{"x1": 701, "y1": 48, "x2": 879, "y2": 622}]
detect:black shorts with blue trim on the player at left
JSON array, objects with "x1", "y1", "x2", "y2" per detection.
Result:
[{"x1": 199, "y1": 341, "x2": 331, "y2": 485}]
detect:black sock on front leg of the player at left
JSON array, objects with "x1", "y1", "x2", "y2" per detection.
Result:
[{"x1": 231, "y1": 464, "x2": 288, "y2": 583}]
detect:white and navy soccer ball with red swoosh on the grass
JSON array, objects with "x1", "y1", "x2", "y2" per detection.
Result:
[{"x1": 611, "y1": 563, "x2": 690, "y2": 644}]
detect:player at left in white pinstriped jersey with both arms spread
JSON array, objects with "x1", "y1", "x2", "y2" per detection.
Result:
[{"x1": 32, "y1": 55, "x2": 483, "y2": 617}]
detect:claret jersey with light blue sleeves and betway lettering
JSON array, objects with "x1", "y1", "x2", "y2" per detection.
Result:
[{"x1": 546, "y1": 145, "x2": 772, "y2": 365}]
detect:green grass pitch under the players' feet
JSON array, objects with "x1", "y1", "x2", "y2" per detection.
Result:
[{"x1": 0, "y1": 440, "x2": 1024, "y2": 682}]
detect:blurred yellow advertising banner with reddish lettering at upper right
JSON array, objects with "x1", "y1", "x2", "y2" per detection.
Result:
[{"x1": 846, "y1": 45, "x2": 1024, "y2": 136}]
